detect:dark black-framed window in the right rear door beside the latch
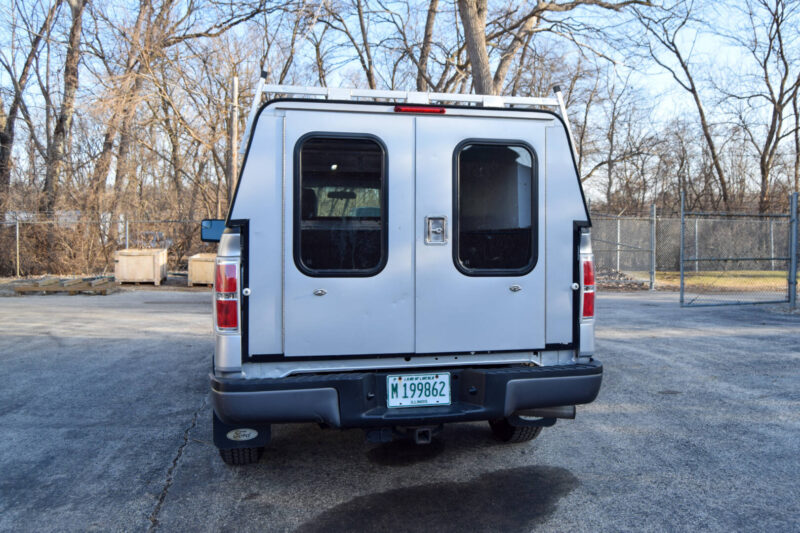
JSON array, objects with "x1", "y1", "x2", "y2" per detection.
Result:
[{"x1": 454, "y1": 143, "x2": 537, "y2": 275}]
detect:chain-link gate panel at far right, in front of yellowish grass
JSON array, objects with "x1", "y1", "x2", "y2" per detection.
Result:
[{"x1": 680, "y1": 193, "x2": 798, "y2": 307}]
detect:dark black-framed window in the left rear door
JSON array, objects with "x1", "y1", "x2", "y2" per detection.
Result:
[{"x1": 294, "y1": 134, "x2": 387, "y2": 276}]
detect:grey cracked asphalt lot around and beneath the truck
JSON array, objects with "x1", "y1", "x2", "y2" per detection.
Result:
[{"x1": 0, "y1": 291, "x2": 800, "y2": 532}]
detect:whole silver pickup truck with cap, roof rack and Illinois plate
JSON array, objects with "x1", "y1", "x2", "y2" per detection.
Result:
[{"x1": 203, "y1": 82, "x2": 602, "y2": 464}]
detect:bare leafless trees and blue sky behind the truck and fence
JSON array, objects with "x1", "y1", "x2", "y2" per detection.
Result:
[{"x1": 0, "y1": 0, "x2": 800, "y2": 271}]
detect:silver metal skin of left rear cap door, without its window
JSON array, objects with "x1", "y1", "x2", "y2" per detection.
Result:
[{"x1": 282, "y1": 110, "x2": 414, "y2": 357}]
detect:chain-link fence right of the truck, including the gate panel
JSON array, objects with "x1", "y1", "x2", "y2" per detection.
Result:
[{"x1": 592, "y1": 192, "x2": 798, "y2": 306}]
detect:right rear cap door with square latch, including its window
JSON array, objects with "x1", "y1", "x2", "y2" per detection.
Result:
[{"x1": 415, "y1": 115, "x2": 548, "y2": 353}]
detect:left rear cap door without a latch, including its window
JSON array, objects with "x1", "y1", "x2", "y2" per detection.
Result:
[{"x1": 282, "y1": 110, "x2": 414, "y2": 357}]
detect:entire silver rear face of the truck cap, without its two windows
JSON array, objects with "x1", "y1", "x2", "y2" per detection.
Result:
[{"x1": 222, "y1": 95, "x2": 588, "y2": 374}]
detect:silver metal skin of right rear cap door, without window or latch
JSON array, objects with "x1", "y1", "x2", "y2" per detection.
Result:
[{"x1": 415, "y1": 115, "x2": 545, "y2": 353}]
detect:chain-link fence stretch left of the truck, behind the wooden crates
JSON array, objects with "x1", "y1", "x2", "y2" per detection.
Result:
[{"x1": 0, "y1": 216, "x2": 216, "y2": 277}]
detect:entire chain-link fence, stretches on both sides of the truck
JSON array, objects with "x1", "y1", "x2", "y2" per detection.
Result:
[{"x1": 0, "y1": 196, "x2": 798, "y2": 305}]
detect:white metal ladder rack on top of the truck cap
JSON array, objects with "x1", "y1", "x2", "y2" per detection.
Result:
[{"x1": 240, "y1": 71, "x2": 578, "y2": 161}]
